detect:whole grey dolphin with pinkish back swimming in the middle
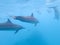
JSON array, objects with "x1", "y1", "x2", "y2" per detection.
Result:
[{"x1": 12, "y1": 13, "x2": 39, "y2": 26}]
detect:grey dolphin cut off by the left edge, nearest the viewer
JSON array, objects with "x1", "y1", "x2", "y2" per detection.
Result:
[{"x1": 0, "y1": 19, "x2": 24, "y2": 34}]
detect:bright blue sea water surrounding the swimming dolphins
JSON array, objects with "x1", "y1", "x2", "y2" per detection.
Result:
[{"x1": 0, "y1": 0, "x2": 60, "y2": 45}]
